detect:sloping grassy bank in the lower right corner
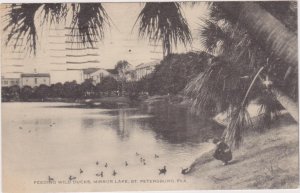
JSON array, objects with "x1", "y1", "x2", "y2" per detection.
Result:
[{"x1": 188, "y1": 115, "x2": 299, "y2": 189}]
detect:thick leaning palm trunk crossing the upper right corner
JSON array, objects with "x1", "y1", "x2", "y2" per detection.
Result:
[{"x1": 221, "y1": 2, "x2": 298, "y2": 68}]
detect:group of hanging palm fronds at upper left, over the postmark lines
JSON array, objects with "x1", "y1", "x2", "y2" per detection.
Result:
[{"x1": 4, "y1": 3, "x2": 109, "y2": 54}]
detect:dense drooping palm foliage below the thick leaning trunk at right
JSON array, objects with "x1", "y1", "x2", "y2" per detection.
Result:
[{"x1": 186, "y1": 2, "x2": 297, "y2": 146}]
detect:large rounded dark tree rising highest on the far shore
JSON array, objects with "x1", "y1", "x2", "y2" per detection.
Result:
[{"x1": 141, "y1": 52, "x2": 212, "y2": 95}]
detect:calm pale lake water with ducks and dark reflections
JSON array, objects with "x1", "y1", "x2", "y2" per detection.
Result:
[{"x1": 2, "y1": 103, "x2": 221, "y2": 192}]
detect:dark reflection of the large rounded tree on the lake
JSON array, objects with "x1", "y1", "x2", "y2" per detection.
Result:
[{"x1": 140, "y1": 104, "x2": 222, "y2": 145}]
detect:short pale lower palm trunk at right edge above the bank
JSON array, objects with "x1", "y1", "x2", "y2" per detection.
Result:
[{"x1": 272, "y1": 88, "x2": 299, "y2": 123}]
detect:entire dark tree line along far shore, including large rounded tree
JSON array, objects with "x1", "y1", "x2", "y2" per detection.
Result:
[{"x1": 2, "y1": 52, "x2": 213, "y2": 101}]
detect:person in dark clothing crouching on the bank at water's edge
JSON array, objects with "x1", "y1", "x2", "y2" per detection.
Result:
[{"x1": 213, "y1": 139, "x2": 232, "y2": 165}]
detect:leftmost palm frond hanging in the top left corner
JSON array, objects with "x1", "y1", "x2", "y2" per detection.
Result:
[{"x1": 4, "y1": 3, "x2": 42, "y2": 54}]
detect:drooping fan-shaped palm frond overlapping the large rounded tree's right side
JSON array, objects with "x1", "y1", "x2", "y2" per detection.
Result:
[{"x1": 184, "y1": 58, "x2": 245, "y2": 114}]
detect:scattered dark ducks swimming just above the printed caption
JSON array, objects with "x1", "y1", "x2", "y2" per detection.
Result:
[{"x1": 48, "y1": 152, "x2": 189, "y2": 181}]
